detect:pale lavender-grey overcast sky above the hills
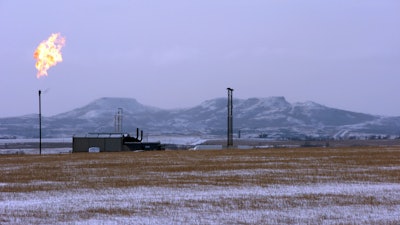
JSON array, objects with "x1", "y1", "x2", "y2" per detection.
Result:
[{"x1": 0, "y1": 0, "x2": 400, "y2": 117}]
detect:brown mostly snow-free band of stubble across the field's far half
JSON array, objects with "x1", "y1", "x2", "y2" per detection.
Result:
[{"x1": 0, "y1": 147, "x2": 400, "y2": 192}]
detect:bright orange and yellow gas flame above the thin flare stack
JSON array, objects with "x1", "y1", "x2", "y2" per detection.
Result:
[{"x1": 33, "y1": 33, "x2": 65, "y2": 78}]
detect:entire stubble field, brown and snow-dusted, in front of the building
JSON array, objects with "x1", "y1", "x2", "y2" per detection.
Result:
[{"x1": 0, "y1": 147, "x2": 400, "y2": 224}]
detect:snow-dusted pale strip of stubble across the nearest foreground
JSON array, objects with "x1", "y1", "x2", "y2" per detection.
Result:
[{"x1": 0, "y1": 183, "x2": 400, "y2": 224}]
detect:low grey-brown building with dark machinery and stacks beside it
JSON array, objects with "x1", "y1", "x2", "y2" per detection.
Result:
[{"x1": 72, "y1": 129, "x2": 164, "y2": 152}]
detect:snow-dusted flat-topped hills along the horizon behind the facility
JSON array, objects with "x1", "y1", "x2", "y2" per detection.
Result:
[{"x1": 0, "y1": 97, "x2": 400, "y2": 139}]
